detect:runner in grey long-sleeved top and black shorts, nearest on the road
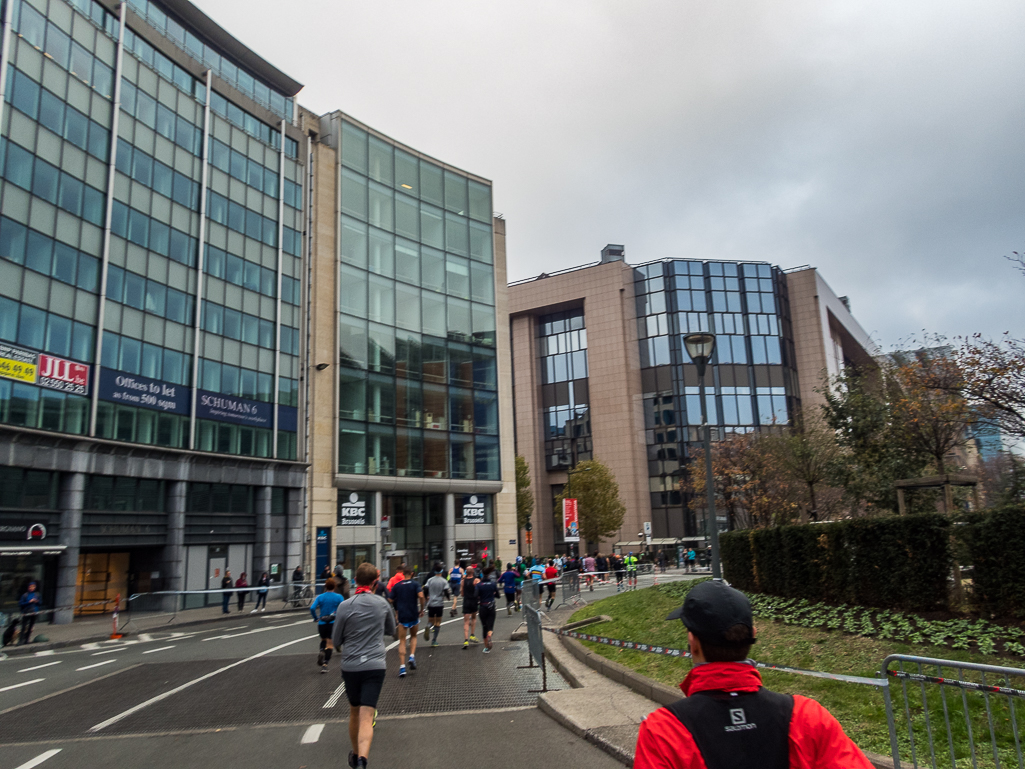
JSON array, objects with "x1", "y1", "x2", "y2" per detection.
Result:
[{"x1": 331, "y1": 562, "x2": 396, "y2": 769}]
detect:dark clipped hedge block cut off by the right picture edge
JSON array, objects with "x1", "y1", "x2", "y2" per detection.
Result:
[{"x1": 958, "y1": 505, "x2": 1025, "y2": 617}]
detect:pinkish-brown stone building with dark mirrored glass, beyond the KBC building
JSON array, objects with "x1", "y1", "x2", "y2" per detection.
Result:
[{"x1": 509, "y1": 245, "x2": 874, "y2": 553}]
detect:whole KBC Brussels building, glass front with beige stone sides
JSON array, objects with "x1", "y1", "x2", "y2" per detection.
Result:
[{"x1": 303, "y1": 112, "x2": 517, "y2": 572}]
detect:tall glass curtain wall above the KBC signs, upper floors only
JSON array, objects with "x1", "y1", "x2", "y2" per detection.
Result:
[{"x1": 337, "y1": 117, "x2": 500, "y2": 481}]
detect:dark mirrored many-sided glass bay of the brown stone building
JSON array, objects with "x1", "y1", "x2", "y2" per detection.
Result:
[{"x1": 633, "y1": 259, "x2": 800, "y2": 536}]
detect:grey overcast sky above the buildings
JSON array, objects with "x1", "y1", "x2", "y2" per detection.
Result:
[{"x1": 196, "y1": 0, "x2": 1025, "y2": 348}]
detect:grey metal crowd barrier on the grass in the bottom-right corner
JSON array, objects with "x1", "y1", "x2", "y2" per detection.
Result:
[{"x1": 879, "y1": 654, "x2": 1025, "y2": 769}]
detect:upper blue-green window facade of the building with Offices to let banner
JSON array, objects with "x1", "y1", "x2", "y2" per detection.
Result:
[{"x1": 0, "y1": 0, "x2": 303, "y2": 459}]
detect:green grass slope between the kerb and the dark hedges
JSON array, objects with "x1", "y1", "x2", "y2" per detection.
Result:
[{"x1": 573, "y1": 583, "x2": 1025, "y2": 766}]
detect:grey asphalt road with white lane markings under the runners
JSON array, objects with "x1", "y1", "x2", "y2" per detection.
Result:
[{"x1": 0, "y1": 586, "x2": 668, "y2": 769}]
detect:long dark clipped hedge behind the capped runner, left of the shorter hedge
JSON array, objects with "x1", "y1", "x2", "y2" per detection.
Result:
[{"x1": 720, "y1": 514, "x2": 951, "y2": 611}]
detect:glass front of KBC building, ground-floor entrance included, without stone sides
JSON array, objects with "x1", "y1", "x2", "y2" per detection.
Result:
[{"x1": 328, "y1": 113, "x2": 501, "y2": 568}]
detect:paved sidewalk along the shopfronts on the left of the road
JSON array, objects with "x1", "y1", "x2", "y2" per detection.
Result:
[{"x1": 3, "y1": 600, "x2": 310, "y2": 656}]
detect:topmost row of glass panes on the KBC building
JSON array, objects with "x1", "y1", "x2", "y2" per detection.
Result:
[{"x1": 341, "y1": 121, "x2": 491, "y2": 224}]
